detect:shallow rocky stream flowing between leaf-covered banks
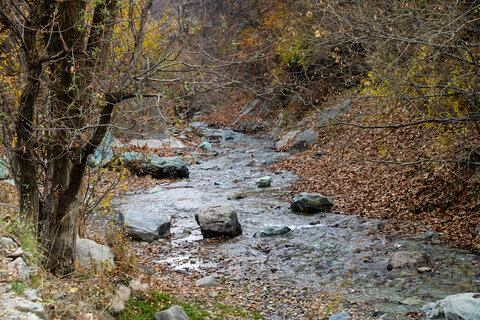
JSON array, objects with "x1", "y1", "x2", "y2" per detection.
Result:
[{"x1": 109, "y1": 123, "x2": 480, "y2": 319}]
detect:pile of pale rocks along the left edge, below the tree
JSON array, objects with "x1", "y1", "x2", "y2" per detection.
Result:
[{"x1": 0, "y1": 237, "x2": 48, "y2": 320}]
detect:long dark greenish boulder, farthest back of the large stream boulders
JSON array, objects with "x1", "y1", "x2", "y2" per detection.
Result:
[{"x1": 118, "y1": 152, "x2": 189, "y2": 179}]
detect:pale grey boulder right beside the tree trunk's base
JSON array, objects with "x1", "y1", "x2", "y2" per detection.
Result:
[{"x1": 75, "y1": 238, "x2": 114, "y2": 268}]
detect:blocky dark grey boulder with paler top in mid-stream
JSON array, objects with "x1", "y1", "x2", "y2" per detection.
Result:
[{"x1": 195, "y1": 203, "x2": 242, "y2": 238}]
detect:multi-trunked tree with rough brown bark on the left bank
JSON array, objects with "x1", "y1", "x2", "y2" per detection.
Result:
[{"x1": 0, "y1": 0, "x2": 165, "y2": 274}]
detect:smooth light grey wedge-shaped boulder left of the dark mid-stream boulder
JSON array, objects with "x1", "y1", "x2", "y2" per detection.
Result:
[{"x1": 120, "y1": 210, "x2": 171, "y2": 242}]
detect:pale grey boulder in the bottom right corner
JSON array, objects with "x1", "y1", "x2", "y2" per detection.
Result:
[{"x1": 422, "y1": 292, "x2": 480, "y2": 320}]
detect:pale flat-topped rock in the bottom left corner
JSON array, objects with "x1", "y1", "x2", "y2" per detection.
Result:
[{"x1": 0, "y1": 292, "x2": 48, "y2": 320}]
